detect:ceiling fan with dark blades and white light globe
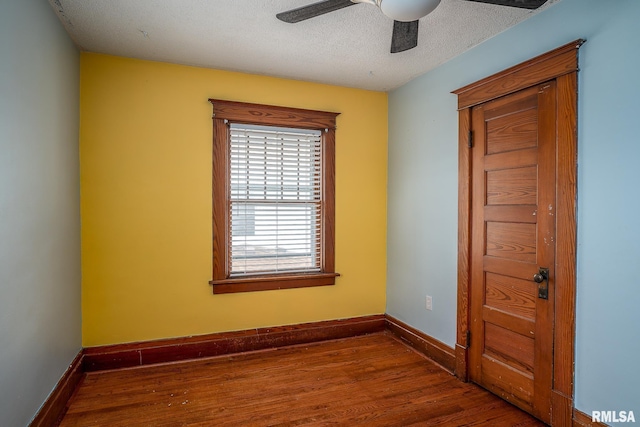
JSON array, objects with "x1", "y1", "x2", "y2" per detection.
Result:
[{"x1": 276, "y1": 0, "x2": 547, "y2": 53}]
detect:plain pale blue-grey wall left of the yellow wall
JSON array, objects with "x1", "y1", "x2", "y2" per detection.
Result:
[{"x1": 0, "y1": 0, "x2": 81, "y2": 427}]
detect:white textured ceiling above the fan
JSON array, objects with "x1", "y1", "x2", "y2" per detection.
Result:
[{"x1": 49, "y1": 0, "x2": 560, "y2": 91}]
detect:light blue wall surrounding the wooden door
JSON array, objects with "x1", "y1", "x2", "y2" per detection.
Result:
[{"x1": 387, "y1": 0, "x2": 640, "y2": 421}]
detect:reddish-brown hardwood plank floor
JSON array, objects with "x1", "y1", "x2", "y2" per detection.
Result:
[{"x1": 60, "y1": 332, "x2": 544, "y2": 427}]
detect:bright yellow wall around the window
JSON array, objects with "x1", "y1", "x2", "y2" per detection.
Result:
[{"x1": 80, "y1": 53, "x2": 387, "y2": 346}]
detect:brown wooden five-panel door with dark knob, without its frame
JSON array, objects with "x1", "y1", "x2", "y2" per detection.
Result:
[{"x1": 469, "y1": 81, "x2": 556, "y2": 423}]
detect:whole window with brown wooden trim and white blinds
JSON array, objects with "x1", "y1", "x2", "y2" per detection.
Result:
[{"x1": 210, "y1": 100, "x2": 338, "y2": 293}]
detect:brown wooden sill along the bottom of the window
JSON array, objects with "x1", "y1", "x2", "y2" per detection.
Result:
[{"x1": 209, "y1": 273, "x2": 340, "y2": 294}]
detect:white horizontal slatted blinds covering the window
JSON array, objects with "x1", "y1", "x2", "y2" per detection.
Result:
[{"x1": 229, "y1": 123, "x2": 322, "y2": 276}]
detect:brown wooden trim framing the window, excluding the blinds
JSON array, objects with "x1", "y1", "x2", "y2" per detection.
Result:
[{"x1": 209, "y1": 99, "x2": 339, "y2": 294}]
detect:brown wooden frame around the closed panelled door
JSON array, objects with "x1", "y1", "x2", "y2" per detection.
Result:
[{"x1": 453, "y1": 39, "x2": 584, "y2": 426}]
